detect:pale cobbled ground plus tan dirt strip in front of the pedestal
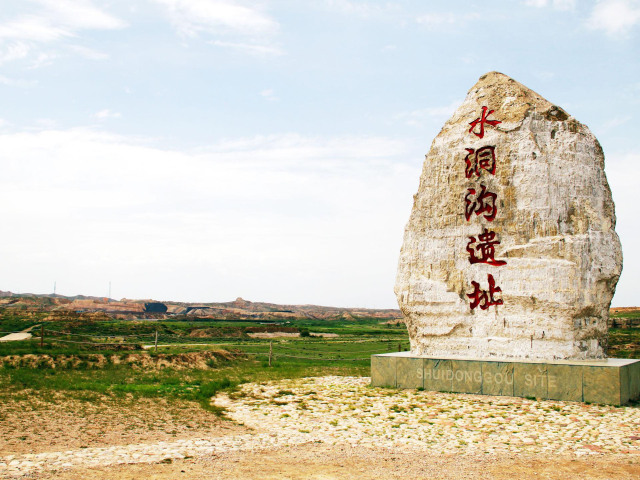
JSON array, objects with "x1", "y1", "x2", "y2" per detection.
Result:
[{"x1": 0, "y1": 377, "x2": 640, "y2": 480}]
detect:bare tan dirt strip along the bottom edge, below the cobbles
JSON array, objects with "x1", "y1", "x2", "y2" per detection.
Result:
[{"x1": 37, "y1": 444, "x2": 640, "y2": 480}]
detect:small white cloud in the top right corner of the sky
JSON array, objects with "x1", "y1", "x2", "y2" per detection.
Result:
[{"x1": 586, "y1": 0, "x2": 640, "y2": 36}]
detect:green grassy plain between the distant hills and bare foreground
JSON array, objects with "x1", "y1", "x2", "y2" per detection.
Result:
[{"x1": 0, "y1": 312, "x2": 640, "y2": 414}]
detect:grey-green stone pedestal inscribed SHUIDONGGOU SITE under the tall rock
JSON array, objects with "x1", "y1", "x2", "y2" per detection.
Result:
[{"x1": 371, "y1": 352, "x2": 640, "y2": 405}]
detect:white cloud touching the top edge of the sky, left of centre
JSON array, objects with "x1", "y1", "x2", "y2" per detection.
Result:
[{"x1": 154, "y1": 0, "x2": 278, "y2": 36}]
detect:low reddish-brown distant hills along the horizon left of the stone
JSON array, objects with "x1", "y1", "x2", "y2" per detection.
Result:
[{"x1": 0, "y1": 291, "x2": 402, "y2": 320}]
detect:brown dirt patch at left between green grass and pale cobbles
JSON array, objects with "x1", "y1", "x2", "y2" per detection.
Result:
[{"x1": 0, "y1": 391, "x2": 247, "y2": 456}]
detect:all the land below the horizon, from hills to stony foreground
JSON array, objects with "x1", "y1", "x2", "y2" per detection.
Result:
[{"x1": 0, "y1": 295, "x2": 640, "y2": 480}]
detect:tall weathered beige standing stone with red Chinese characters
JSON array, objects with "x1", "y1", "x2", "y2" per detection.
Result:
[{"x1": 395, "y1": 72, "x2": 622, "y2": 359}]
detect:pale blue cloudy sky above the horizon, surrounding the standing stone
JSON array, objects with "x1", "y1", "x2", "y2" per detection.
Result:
[{"x1": 0, "y1": 0, "x2": 640, "y2": 308}]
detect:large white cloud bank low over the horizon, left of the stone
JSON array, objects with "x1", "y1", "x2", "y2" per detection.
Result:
[{"x1": 0, "y1": 129, "x2": 421, "y2": 307}]
